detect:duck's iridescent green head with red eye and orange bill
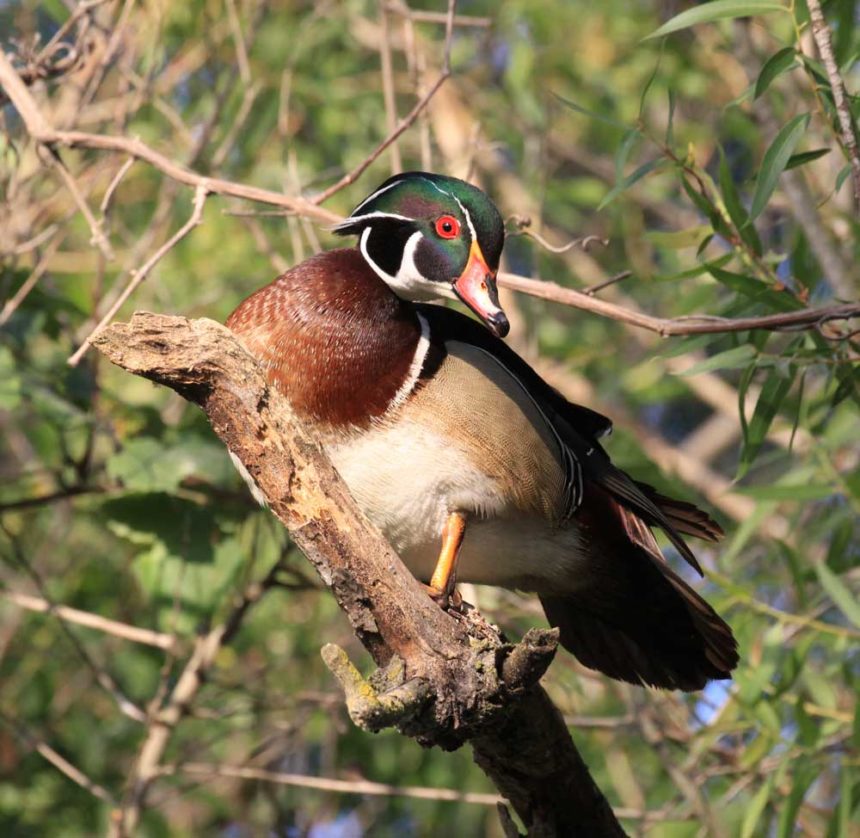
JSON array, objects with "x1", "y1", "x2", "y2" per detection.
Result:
[{"x1": 334, "y1": 172, "x2": 510, "y2": 337}]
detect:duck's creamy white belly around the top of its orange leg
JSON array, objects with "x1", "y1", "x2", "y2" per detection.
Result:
[{"x1": 326, "y1": 421, "x2": 581, "y2": 591}]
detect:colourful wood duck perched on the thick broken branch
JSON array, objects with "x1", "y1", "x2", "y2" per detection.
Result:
[{"x1": 227, "y1": 172, "x2": 738, "y2": 690}]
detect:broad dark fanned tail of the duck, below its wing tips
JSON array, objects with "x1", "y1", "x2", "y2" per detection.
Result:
[{"x1": 540, "y1": 545, "x2": 738, "y2": 691}]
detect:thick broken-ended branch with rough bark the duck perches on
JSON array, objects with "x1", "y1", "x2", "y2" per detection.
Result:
[{"x1": 94, "y1": 313, "x2": 624, "y2": 836}]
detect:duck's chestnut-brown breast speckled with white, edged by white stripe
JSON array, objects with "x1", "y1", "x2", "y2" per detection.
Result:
[{"x1": 227, "y1": 248, "x2": 420, "y2": 428}]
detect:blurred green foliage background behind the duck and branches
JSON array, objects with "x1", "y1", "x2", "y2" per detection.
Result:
[{"x1": 0, "y1": 0, "x2": 860, "y2": 838}]
